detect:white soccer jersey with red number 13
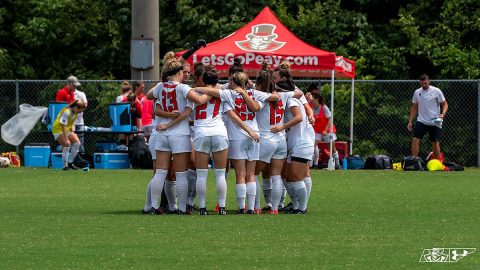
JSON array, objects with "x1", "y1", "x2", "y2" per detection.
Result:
[{"x1": 153, "y1": 81, "x2": 194, "y2": 135}]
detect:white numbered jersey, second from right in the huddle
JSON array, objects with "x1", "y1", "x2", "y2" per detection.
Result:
[{"x1": 257, "y1": 91, "x2": 295, "y2": 142}]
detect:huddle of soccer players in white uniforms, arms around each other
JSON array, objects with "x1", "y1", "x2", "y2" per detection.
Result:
[{"x1": 143, "y1": 41, "x2": 315, "y2": 215}]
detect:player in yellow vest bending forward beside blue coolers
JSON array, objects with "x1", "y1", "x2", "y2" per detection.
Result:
[{"x1": 52, "y1": 100, "x2": 85, "y2": 171}]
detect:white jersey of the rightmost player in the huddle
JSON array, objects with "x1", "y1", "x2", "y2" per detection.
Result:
[{"x1": 284, "y1": 98, "x2": 313, "y2": 150}]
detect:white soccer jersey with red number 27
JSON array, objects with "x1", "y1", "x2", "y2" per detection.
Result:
[{"x1": 194, "y1": 90, "x2": 230, "y2": 139}]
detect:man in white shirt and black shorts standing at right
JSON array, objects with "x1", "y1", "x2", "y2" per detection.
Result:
[{"x1": 407, "y1": 74, "x2": 448, "y2": 159}]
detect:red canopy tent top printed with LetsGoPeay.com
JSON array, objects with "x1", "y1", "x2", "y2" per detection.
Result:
[{"x1": 177, "y1": 7, "x2": 355, "y2": 78}]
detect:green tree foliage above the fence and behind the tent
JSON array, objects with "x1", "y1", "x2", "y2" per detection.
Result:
[{"x1": 0, "y1": 0, "x2": 480, "y2": 79}]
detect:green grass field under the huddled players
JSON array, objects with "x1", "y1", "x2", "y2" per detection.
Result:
[{"x1": 0, "y1": 168, "x2": 480, "y2": 269}]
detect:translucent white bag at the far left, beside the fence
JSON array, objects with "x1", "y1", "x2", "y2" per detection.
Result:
[{"x1": 2, "y1": 104, "x2": 48, "y2": 145}]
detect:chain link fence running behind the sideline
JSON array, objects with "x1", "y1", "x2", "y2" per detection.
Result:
[{"x1": 0, "y1": 80, "x2": 480, "y2": 166}]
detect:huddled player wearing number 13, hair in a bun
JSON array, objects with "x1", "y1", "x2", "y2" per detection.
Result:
[{"x1": 147, "y1": 52, "x2": 211, "y2": 214}]
